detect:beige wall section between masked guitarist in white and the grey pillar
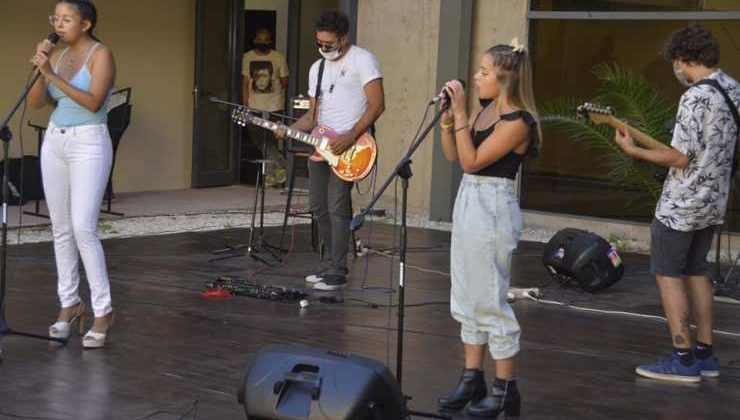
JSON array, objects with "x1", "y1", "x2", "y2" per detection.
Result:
[{"x1": 354, "y1": 0, "x2": 440, "y2": 214}]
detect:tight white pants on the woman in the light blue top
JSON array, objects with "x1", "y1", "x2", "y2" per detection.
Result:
[{"x1": 41, "y1": 122, "x2": 113, "y2": 317}]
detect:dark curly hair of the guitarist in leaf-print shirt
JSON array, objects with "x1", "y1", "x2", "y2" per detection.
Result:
[{"x1": 663, "y1": 23, "x2": 719, "y2": 67}]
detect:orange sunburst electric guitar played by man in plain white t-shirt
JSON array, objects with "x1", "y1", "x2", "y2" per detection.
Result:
[{"x1": 231, "y1": 107, "x2": 378, "y2": 182}]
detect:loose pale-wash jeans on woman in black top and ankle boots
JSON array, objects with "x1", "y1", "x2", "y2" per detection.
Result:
[{"x1": 450, "y1": 174, "x2": 522, "y2": 360}]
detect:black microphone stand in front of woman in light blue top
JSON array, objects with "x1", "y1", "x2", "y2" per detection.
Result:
[{"x1": 0, "y1": 70, "x2": 67, "y2": 354}]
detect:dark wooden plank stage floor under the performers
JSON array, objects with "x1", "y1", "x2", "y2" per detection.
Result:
[{"x1": 0, "y1": 225, "x2": 740, "y2": 420}]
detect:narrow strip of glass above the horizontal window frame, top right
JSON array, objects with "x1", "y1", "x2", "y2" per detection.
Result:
[{"x1": 531, "y1": 0, "x2": 740, "y2": 12}]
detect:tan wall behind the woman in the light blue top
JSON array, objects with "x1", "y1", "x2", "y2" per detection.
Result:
[{"x1": 0, "y1": 0, "x2": 195, "y2": 192}]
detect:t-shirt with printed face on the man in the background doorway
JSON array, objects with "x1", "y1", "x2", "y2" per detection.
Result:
[{"x1": 242, "y1": 50, "x2": 288, "y2": 112}]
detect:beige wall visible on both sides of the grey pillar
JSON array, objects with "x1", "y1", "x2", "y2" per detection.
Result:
[{"x1": 355, "y1": 0, "x2": 529, "y2": 215}]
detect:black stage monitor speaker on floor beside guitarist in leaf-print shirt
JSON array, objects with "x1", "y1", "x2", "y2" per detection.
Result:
[{"x1": 542, "y1": 228, "x2": 624, "y2": 292}]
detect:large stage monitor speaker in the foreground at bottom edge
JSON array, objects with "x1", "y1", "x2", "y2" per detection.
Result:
[{"x1": 238, "y1": 345, "x2": 408, "y2": 420}]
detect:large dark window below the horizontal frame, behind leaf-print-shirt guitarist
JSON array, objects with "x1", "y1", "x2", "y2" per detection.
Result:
[{"x1": 523, "y1": 19, "x2": 740, "y2": 230}]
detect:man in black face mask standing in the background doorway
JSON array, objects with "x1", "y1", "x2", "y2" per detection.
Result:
[{"x1": 242, "y1": 28, "x2": 288, "y2": 186}]
